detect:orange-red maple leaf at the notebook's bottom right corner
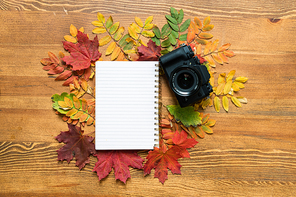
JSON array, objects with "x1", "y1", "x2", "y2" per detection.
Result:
[{"x1": 144, "y1": 145, "x2": 182, "y2": 183}]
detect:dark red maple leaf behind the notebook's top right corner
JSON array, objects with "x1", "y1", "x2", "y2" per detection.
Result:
[{"x1": 138, "y1": 40, "x2": 161, "y2": 61}]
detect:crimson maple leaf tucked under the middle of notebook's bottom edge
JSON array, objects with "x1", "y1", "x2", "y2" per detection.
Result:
[{"x1": 93, "y1": 150, "x2": 144, "y2": 183}]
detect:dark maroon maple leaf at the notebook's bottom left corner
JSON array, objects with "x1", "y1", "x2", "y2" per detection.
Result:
[{"x1": 56, "y1": 124, "x2": 95, "y2": 170}]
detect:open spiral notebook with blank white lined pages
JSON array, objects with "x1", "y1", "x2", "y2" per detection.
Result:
[{"x1": 95, "y1": 61, "x2": 159, "y2": 150}]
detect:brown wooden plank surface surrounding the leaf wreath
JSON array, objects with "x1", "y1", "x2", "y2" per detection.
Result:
[{"x1": 0, "y1": 0, "x2": 296, "y2": 196}]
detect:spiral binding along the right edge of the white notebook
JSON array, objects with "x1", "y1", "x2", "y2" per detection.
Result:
[{"x1": 154, "y1": 64, "x2": 159, "y2": 147}]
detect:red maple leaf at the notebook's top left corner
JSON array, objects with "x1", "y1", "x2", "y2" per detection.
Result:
[{"x1": 63, "y1": 31, "x2": 101, "y2": 70}]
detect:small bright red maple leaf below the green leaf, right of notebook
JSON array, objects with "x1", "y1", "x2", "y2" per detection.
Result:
[{"x1": 173, "y1": 130, "x2": 198, "y2": 158}]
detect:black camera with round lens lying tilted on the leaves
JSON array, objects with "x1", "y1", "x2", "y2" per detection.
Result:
[{"x1": 159, "y1": 45, "x2": 213, "y2": 107}]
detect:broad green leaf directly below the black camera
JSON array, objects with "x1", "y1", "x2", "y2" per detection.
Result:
[{"x1": 166, "y1": 105, "x2": 201, "y2": 127}]
